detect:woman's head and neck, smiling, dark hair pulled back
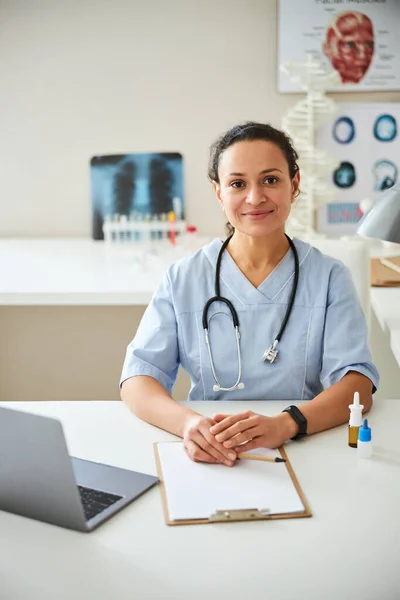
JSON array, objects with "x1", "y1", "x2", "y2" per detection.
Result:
[{"x1": 208, "y1": 122, "x2": 300, "y2": 287}]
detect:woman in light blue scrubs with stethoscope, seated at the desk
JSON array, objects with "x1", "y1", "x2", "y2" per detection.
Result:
[{"x1": 121, "y1": 122, "x2": 379, "y2": 466}]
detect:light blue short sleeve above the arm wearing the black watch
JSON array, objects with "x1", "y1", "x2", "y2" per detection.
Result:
[{"x1": 320, "y1": 265, "x2": 379, "y2": 393}]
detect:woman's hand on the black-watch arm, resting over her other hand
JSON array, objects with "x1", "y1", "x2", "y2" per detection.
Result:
[{"x1": 210, "y1": 410, "x2": 297, "y2": 452}]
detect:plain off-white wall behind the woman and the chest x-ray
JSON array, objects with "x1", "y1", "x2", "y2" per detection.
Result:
[{"x1": 0, "y1": 0, "x2": 399, "y2": 236}]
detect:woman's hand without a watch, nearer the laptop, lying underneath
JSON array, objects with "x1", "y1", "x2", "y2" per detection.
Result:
[{"x1": 183, "y1": 415, "x2": 237, "y2": 467}]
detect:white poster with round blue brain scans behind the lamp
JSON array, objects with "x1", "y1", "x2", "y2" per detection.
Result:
[{"x1": 316, "y1": 102, "x2": 400, "y2": 237}]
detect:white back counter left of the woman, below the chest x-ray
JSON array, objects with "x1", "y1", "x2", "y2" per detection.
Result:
[{"x1": 0, "y1": 238, "x2": 197, "y2": 306}]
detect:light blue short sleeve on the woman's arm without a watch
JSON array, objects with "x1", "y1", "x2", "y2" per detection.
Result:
[{"x1": 120, "y1": 273, "x2": 179, "y2": 393}]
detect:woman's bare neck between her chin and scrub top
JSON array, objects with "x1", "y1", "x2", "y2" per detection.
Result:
[{"x1": 227, "y1": 230, "x2": 289, "y2": 275}]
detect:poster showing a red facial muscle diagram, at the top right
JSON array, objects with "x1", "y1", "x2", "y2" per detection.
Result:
[{"x1": 278, "y1": 0, "x2": 400, "y2": 92}]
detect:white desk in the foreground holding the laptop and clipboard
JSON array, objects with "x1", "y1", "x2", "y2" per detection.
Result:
[{"x1": 0, "y1": 400, "x2": 400, "y2": 600}]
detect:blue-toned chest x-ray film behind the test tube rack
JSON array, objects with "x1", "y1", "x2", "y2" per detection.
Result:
[{"x1": 90, "y1": 152, "x2": 184, "y2": 240}]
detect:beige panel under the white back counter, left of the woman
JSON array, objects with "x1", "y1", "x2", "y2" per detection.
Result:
[{"x1": 0, "y1": 306, "x2": 189, "y2": 402}]
